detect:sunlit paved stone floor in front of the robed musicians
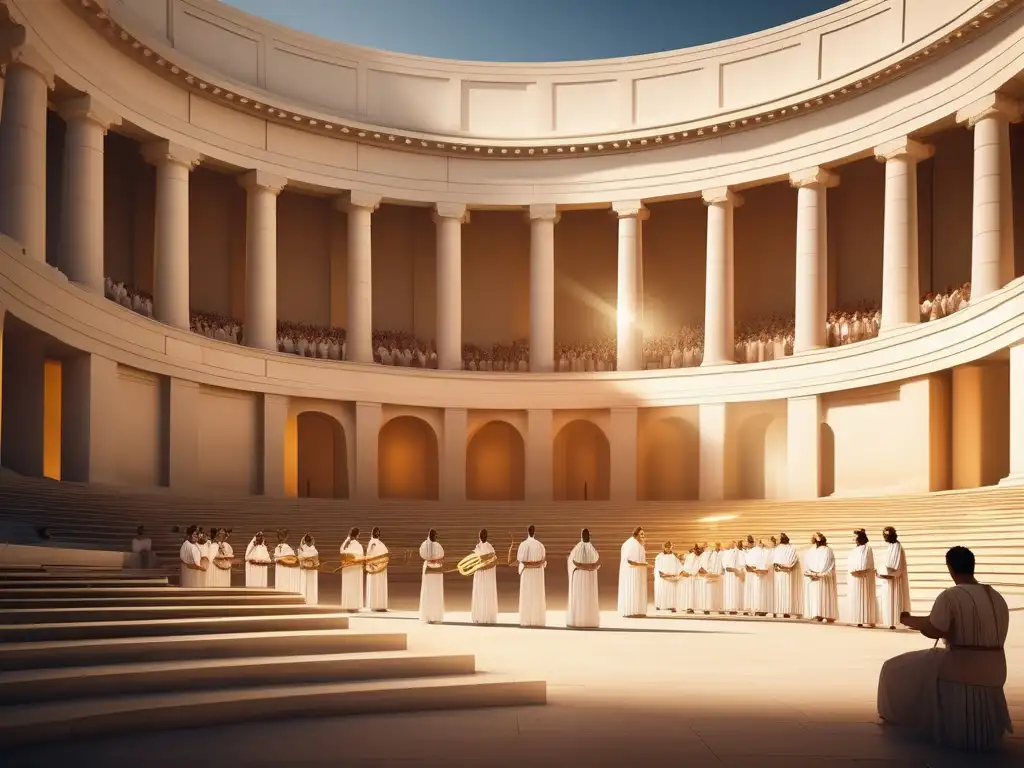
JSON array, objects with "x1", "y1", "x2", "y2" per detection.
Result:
[{"x1": 4, "y1": 584, "x2": 1024, "y2": 768}]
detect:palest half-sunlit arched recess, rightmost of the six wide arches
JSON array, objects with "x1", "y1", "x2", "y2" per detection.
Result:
[{"x1": 736, "y1": 414, "x2": 787, "y2": 499}]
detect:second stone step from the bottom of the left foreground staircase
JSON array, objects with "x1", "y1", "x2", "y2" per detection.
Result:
[{"x1": 0, "y1": 651, "x2": 476, "y2": 707}]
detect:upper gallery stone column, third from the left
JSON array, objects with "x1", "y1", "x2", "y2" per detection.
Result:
[{"x1": 142, "y1": 140, "x2": 202, "y2": 331}]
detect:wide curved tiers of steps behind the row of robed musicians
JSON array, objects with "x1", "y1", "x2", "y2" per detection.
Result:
[{"x1": 0, "y1": 472, "x2": 1024, "y2": 610}]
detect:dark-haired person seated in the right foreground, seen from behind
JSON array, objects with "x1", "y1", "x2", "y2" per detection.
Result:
[{"x1": 878, "y1": 547, "x2": 1013, "y2": 751}]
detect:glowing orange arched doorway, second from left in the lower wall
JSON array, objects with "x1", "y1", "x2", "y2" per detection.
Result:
[{"x1": 377, "y1": 416, "x2": 437, "y2": 501}]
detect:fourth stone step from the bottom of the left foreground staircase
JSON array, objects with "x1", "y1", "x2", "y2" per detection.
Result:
[{"x1": 0, "y1": 612, "x2": 348, "y2": 643}]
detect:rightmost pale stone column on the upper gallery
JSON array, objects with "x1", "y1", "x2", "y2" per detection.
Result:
[{"x1": 956, "y1": 93, "x2": 1021, "y2": 301}]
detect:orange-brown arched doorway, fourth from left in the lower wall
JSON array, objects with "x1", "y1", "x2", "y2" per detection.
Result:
[{"x1": 553, "y1": 419, "x2": 611, "y2": 501}]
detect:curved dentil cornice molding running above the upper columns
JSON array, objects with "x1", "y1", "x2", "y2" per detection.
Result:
[{"x1": 58, "y1": 0, "x2": 1024, "y2": 160}]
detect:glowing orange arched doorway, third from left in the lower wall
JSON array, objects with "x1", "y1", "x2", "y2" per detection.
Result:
[{"x1": 466, "y1": 421, "x2": 526, "y2": 501}]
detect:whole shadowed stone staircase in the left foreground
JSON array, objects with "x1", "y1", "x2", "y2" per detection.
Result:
[{"x1": 0, "y1": 567, "x2": 547, "y2": 748}]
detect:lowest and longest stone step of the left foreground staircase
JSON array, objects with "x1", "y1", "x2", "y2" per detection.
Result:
[{"x1": 0, "y1": 674, "x2": 547, "y2": 746}]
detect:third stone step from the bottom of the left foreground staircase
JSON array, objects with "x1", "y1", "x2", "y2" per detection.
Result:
[{"x1": 0, "y1": 630, "x2": 408, "y2": 674}]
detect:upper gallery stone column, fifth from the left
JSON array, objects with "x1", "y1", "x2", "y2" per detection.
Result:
[{"x1": 336, "y1": 191, "x2": 381, "y2": 362}]
